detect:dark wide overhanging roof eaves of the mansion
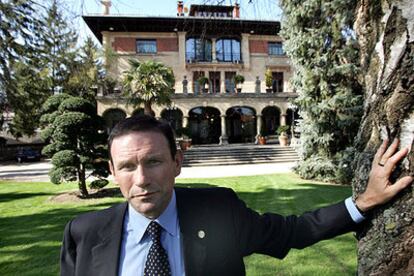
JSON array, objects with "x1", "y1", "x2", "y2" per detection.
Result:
[{"x1": 83, "y1": 15, "x2": 280, "y2": 43}]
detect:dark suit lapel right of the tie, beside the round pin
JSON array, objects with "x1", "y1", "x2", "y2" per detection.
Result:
[{"x1": 175, "y1": 188, "x2": 207, "y2": 275}]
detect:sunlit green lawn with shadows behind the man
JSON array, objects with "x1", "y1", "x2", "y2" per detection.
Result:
[{"x1": 0, "y1": 174, "x2": 356, "y2": 276}]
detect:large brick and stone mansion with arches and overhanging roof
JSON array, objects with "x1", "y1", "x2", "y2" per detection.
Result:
[{"x1": 83, "y1": 1, "x2": 296, "y2": 144}]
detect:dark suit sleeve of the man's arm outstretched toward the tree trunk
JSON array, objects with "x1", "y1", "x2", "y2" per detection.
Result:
[{"x1": 226, "y1": 192, "x2": 356, "y2": 258}]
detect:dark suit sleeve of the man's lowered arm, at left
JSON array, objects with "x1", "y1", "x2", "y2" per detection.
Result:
[{"x1": 60, "y1": 221, "x2": 76, "y2": 276}]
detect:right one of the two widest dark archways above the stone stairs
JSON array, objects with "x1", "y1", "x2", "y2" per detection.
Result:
[{"x1": 226, "y1": 106, "x2": 256, "y2": 143}]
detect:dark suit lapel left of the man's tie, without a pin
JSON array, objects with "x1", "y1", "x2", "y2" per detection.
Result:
[{"x1": 92, "y1": 202, "x2": 128, "y2": 276}]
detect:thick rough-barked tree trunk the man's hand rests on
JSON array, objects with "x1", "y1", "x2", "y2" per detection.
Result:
[{"x1": 353, "y1": 0, "x2": 414, "y2": 275}]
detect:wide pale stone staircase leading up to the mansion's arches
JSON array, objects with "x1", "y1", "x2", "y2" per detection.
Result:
[{"x1": 183, "y1": 144, "x2": 299, "y2": 167}]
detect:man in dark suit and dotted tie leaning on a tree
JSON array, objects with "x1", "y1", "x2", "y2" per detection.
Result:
[{"x1": 61, "y1": 116, "x2": 413, "y2": 275}]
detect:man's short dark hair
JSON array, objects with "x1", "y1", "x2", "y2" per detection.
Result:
[{"x1": 108, "y1": 115, "x2": 177, "y2": 162}]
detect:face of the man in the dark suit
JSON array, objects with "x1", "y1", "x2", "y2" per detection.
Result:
[{"x1": 109, "y1": 131, "x2": 183, "y2": 219}]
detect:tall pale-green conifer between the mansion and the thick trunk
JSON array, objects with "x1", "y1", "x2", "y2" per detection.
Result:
[{"x1": 281, "y1": 0, "x2": 363, "y2": 185}]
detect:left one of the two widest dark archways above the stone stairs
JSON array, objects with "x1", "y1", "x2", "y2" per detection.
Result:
[{"x1": 188, "y1": 107, "x2": 221, "y2": 145}]
